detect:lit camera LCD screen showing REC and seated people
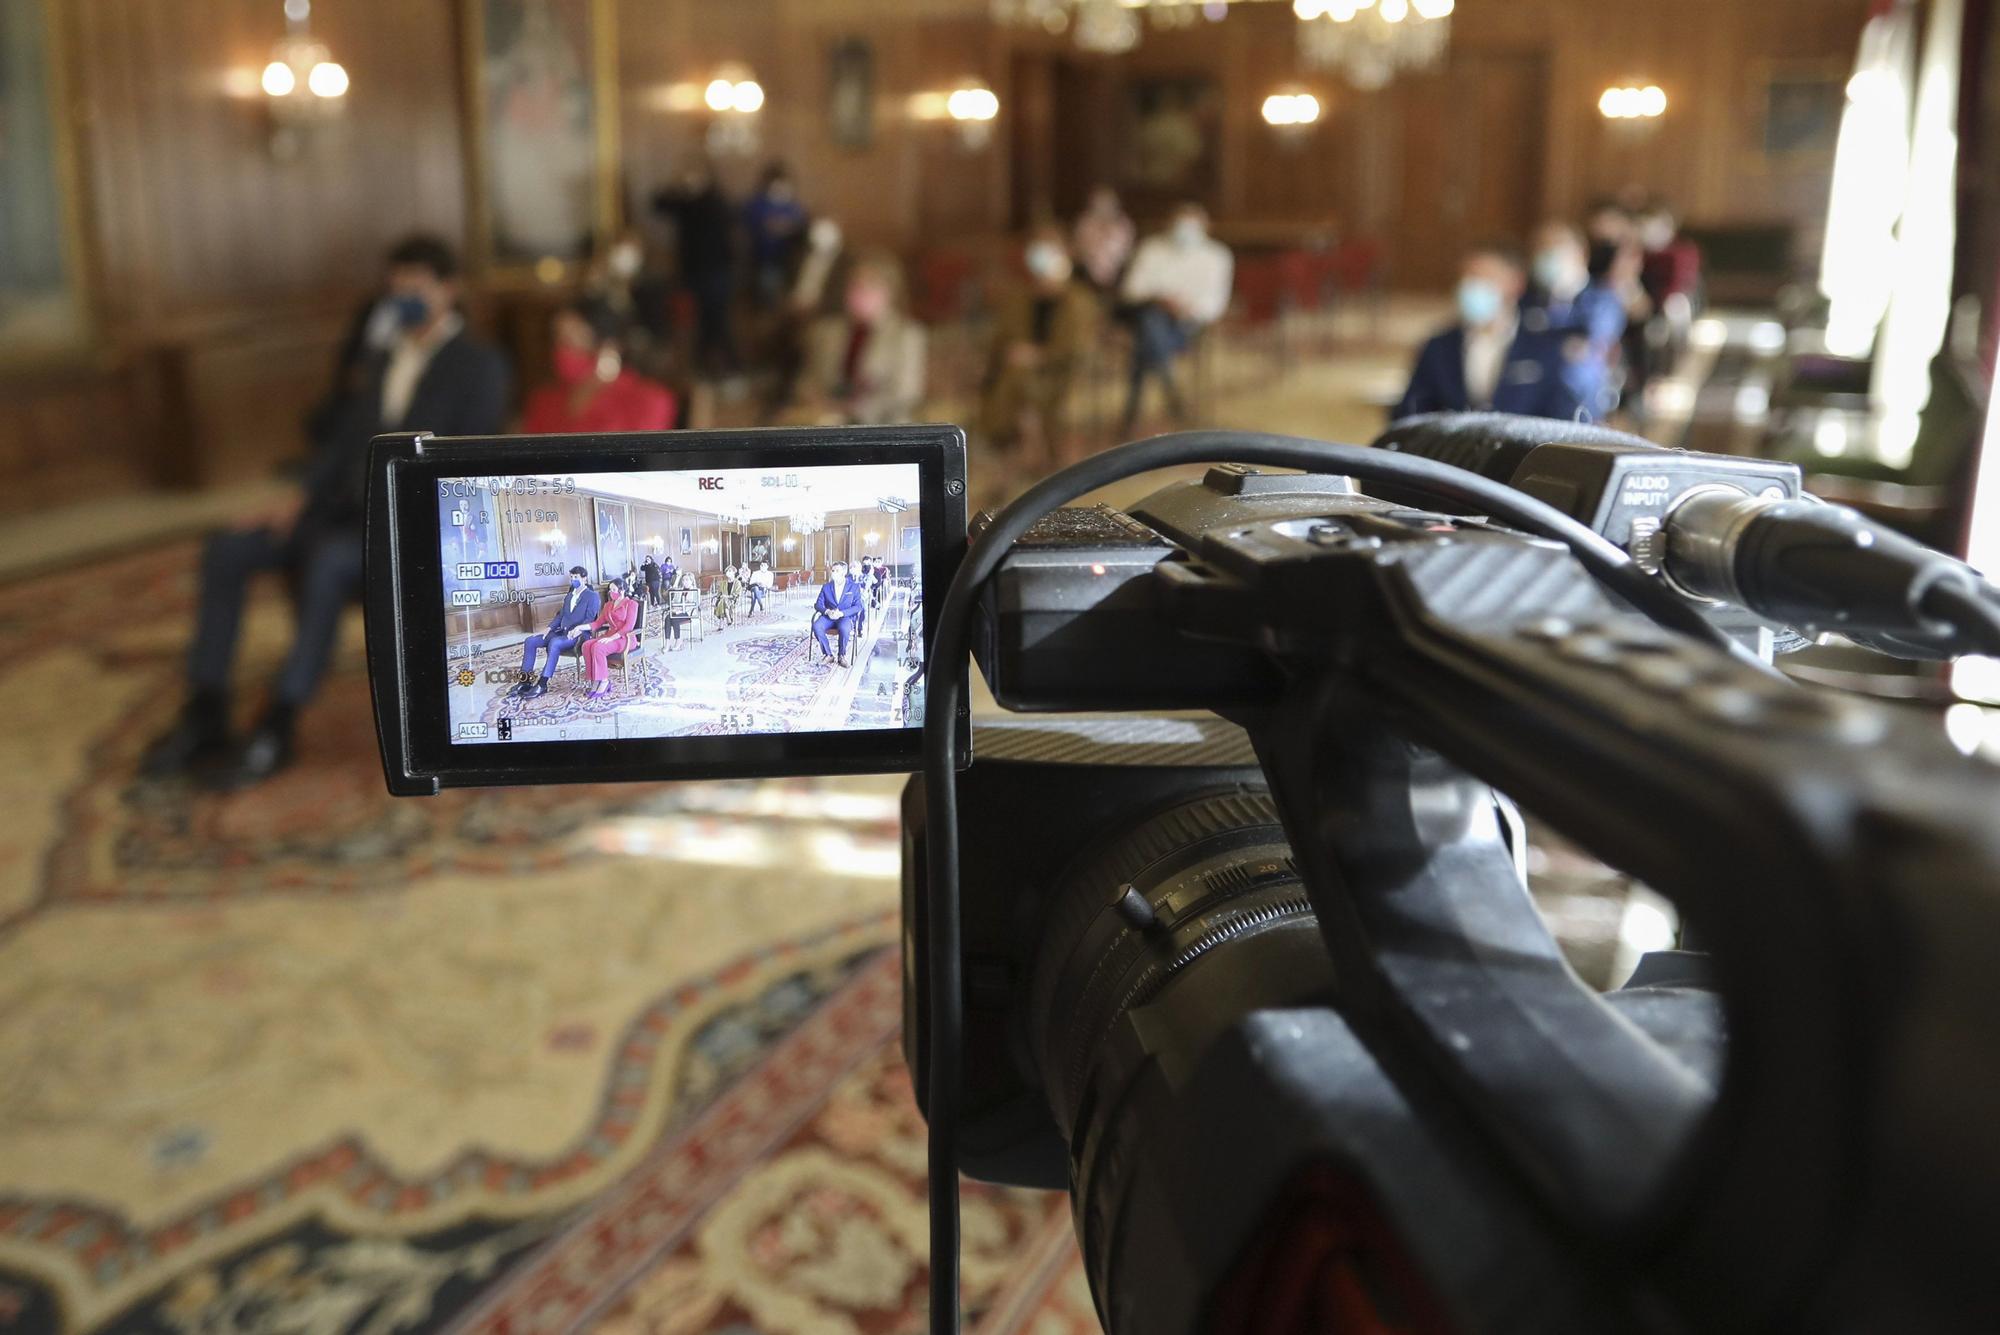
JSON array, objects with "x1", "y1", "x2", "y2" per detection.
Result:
[{"x1": 436, "y1": 464, "x2": 924, "y2": 747}]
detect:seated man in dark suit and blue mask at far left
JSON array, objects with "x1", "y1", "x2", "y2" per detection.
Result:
[{"x1": 142, "y1": 236, "x2": 508, "y2": 787}]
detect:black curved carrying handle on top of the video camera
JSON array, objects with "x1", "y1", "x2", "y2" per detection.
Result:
[{"x1": 1158, "y1": 520, "x2": 2000, "y2": 1329}]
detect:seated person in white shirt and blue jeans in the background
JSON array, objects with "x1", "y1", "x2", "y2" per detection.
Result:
[{"x1": 1120, "y1": 202, "x2": 1236, "y2": 436}]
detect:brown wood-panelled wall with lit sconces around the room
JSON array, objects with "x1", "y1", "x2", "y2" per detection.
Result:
[{"x1": 0, "y1": 0, "x2": 1868, "y2": 508}]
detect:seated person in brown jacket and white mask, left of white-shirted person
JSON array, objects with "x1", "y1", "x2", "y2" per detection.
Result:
[{"x1": 980, "y1": 228, "x2": 1100, "y2": 472}]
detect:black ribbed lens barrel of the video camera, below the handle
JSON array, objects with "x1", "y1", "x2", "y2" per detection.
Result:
[{"x1": 1030, "y1": 787, "x2": 1332, "y2": 1329}]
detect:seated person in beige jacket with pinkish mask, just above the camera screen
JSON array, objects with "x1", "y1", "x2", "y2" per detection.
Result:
[{"x1": 796, "y1": 254, "x2": 930, "y2": 426}]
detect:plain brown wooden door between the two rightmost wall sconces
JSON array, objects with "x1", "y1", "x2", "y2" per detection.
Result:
[{"x1": 1390, "y1": 52, "x2": 1548, "y2": 290}]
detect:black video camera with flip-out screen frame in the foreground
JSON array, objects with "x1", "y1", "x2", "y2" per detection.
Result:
[{"x1": 368, "y1": 418, "x2": 2000, "y2": 1335}]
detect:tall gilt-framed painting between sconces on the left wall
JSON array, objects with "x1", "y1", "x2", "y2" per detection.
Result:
[{"x1": 460, "y1": 0, "x2": 618, "y2": 280}]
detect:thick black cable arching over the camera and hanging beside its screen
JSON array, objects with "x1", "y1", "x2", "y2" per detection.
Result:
[{"x1": 924, "y1": 432, "x2": 1762, "y2": 1335}]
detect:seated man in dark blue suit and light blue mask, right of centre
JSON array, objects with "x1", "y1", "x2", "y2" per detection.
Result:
[{"x1": 1392, "y1": 246, "x2": 1590, "y2": 420}]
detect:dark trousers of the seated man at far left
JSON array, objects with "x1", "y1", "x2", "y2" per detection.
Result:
[{"x1": 188, "y1": 528, "x2": 362, "y2": 709}]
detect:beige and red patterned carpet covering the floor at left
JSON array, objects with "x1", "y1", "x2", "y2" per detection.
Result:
[{"x1": 0, "y1": 548, "x2": 1094, "y2": 1335}]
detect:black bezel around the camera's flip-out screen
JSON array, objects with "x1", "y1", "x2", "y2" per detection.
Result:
[{"x1": 376, "y1": 426, "x2": 970, "y2": 793}]
